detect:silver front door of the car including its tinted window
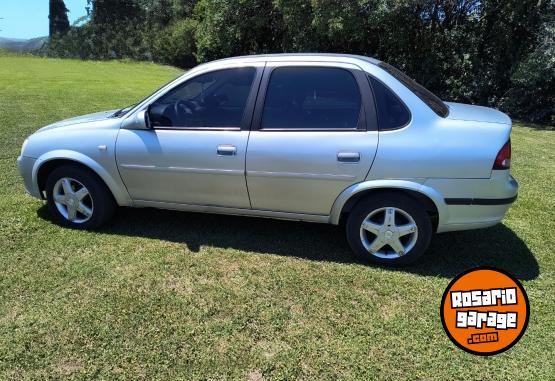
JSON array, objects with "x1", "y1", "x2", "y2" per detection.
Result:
[{"x1": 116, "y1": 65, "x2": 263, "y2": 208}]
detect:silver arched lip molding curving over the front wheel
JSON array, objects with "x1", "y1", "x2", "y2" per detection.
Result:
[{"x1": 32, "y1": 150, "x2": 133, "y2": 206}]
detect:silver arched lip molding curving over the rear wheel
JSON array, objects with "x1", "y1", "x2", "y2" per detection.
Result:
[{"x1": 329, "y1": 179, "x2": 449, "y2": 226}]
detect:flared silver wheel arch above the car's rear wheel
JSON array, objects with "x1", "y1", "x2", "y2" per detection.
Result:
[{"x1": 330, "y1": 180, "x2": 448, "y2": 230}]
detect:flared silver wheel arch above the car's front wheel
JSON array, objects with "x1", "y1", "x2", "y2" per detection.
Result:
[{"x1": 32, "y1": 150, "x2": 132, "y2": 206}]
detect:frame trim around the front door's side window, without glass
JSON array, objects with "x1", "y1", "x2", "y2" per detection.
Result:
[{"x1": 148, "y1": 65, "x2": 264, "y2": 131}]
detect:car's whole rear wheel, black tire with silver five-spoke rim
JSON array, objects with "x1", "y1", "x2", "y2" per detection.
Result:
[{"x1": 346, "y1": 193, "x2": 432, "y2": 266}]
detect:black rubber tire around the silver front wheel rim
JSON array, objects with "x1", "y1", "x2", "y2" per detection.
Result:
[{"x1": 46, "y1": 165, "x2": 117, "y2": 229}]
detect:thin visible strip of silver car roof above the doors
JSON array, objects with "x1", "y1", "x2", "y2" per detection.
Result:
[{"x1": 200, "y1": 53, "x2": 380, "y2": 65}]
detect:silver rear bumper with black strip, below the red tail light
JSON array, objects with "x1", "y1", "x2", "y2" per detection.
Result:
[{"x1": 426, "y1": 171, "x2": 518, "y2": 233}]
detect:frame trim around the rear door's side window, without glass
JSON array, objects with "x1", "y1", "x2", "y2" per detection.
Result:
[{"x1": 251, "y1": 62, "x2": 378, "y2": 132}]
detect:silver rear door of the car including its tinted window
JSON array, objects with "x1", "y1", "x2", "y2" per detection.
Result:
[{"x1": 246, "y1": 62, "x2": 378, "y2": 215}]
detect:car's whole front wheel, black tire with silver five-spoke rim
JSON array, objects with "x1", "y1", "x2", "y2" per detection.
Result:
[{"x1": 46, "y1": 165, "x2": 116, "y2": 229}]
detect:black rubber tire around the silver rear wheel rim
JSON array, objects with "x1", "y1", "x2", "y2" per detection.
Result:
[{"x1": 346, "y1": 193, "x2": 432, "y2": 267}]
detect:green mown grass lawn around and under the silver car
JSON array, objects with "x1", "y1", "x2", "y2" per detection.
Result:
[{"x1": 0, "y1": 55, "x2": 555, "y2": 380}]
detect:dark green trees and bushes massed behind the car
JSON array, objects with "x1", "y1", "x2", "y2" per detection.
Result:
[{"x1": 45, "y1": 0, "x2": 555, "y2": 124}]
